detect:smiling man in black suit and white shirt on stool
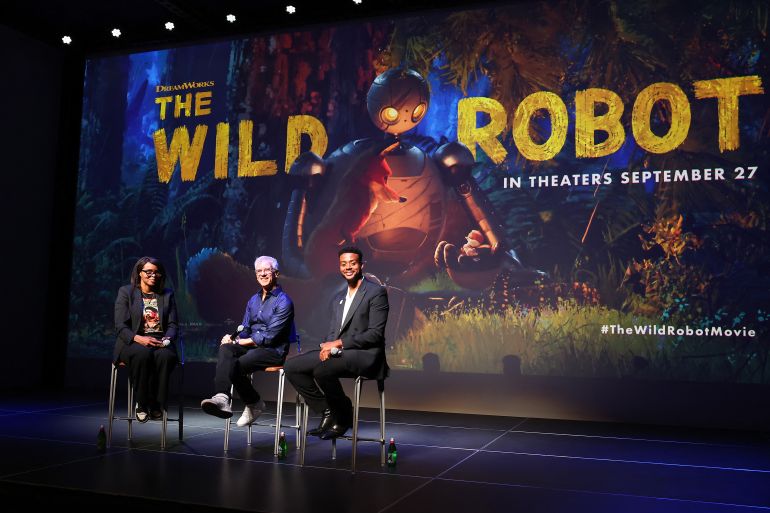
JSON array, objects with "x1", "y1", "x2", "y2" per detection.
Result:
[{"x1": 284, "y1": 246, "x2": 388, "y2": 440}]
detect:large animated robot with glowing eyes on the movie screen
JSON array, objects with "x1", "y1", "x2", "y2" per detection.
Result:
[{"x1": 282, "y1": 69, "x2": 521, "y2": 289}]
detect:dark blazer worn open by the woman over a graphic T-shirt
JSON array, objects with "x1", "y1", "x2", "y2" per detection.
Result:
[{"x1": 112, "y1": 285, "x2": 178, "y2": 363}]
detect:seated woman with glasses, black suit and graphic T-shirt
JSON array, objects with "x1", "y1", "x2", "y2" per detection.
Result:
[{"x1": 113, "y1": 257, "x2": 178, "y2": 422}]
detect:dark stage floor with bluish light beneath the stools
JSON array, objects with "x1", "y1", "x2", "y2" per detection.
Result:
[{"x1": 0, "y1": 391, "x2": 770, "y2": 513}]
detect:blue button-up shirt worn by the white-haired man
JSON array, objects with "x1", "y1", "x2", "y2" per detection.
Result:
[{"x1": 240, "y1": 285, "x2": 297, "y2": 356}]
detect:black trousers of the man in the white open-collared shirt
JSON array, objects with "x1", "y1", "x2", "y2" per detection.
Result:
[{"x1": 284, "y1": 350, "x2": 360, "y2": 417}]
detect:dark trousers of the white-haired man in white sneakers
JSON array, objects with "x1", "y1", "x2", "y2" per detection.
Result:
[{"x1": 214, "y1": 344, "x2": 285, "y2": 404}]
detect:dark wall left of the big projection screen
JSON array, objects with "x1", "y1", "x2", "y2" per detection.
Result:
[{"x1": 0, "y1": 26, "x2": 63, "y2": 389}]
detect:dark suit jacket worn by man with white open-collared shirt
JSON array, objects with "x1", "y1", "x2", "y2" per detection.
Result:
[{"x1": 326, "y1": 278, "x2": 388, "y2": 379}]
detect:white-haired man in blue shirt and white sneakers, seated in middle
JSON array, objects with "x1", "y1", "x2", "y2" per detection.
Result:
[{"x1": 201, "y1": 256, "x2": 297, "y2": 426}]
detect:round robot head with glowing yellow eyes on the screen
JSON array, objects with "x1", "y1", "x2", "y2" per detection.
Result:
[{"x1": 366, "y1": 69, "x2": 430, "y2": 135}]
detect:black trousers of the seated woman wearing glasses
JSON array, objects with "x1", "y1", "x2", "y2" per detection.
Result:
[{"x1": 119, "y1": 342, "x2": 179, "y2": 409}]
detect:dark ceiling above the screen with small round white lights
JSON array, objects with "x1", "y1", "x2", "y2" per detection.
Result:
[{"x1": 0, "y1": 0, "x2": 498, "y2": 55}]
